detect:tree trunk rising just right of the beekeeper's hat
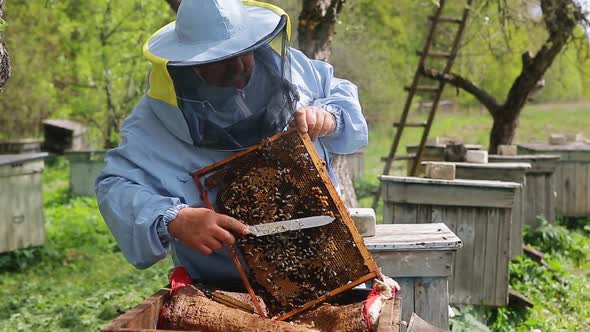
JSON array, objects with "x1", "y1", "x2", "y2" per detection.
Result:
[{"x1": 297, "y1": 0, "x2": 344, "y2": 61}]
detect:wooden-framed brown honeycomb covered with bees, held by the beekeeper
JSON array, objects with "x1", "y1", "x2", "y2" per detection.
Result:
[{"x1": 193, "y1": 130, "x2": 379, "y2": 320}]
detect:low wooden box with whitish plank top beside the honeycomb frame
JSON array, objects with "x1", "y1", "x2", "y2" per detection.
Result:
[{"x1": 365, "y1": 223, "x2": 462, "y2": 332}]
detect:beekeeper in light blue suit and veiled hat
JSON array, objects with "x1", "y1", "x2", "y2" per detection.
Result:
[{"x1": 96, "y1": 0, "x2": 367, "y2": 283}]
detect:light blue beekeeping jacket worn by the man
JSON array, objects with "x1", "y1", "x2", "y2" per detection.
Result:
[{"x1": 96, "y1": 49, "x2": 368, "y2": 282}]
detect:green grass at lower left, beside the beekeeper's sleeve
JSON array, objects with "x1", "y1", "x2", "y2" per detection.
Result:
[{"x1": 0, "y1": 158, "x2": 172, "y2": 331}]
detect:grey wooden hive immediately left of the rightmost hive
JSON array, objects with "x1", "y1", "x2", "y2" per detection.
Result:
[{"x1": 488, "y1": 154, "x2": 559, "y2": 228}]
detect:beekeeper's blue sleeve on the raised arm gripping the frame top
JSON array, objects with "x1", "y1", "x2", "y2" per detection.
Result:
[{"x1": 291, "y1": 49, "x2": 369, "y2": 154}]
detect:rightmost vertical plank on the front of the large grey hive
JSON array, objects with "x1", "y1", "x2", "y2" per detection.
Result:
[{"x1": 495, "y1": 210, "x2": 511, "y2": 306}]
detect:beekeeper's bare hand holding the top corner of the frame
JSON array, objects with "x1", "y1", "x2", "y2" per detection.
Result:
[{"x1": 291, "y1": 106, "x2": 336, "y2": 141}]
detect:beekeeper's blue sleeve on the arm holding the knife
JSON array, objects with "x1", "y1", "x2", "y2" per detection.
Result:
[{"x1": 96, "y1": 132, "x2": 181, "y2": 269}]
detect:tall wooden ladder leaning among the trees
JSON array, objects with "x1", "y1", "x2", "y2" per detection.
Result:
[{"x1": 373, "y1": 0, "x2": 473, "y2": 209}]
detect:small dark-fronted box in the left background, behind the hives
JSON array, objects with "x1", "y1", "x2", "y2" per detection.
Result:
[{"x1": 42, "y1": 119, "x2": 86, "y2": 153}]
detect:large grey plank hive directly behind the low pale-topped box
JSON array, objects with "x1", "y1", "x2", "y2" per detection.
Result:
[{"x1": 380, "y1": 176, "x2": 520, "y2": 306}]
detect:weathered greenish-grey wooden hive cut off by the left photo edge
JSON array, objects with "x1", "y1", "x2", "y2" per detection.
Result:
[{"x1": 0, "y1": 153, "x2": 47, "y2": 253}]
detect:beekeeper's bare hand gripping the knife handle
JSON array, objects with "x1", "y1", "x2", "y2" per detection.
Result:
[{"x1": 168, "y1": 207, "x2": 249, "y2": 255}]
